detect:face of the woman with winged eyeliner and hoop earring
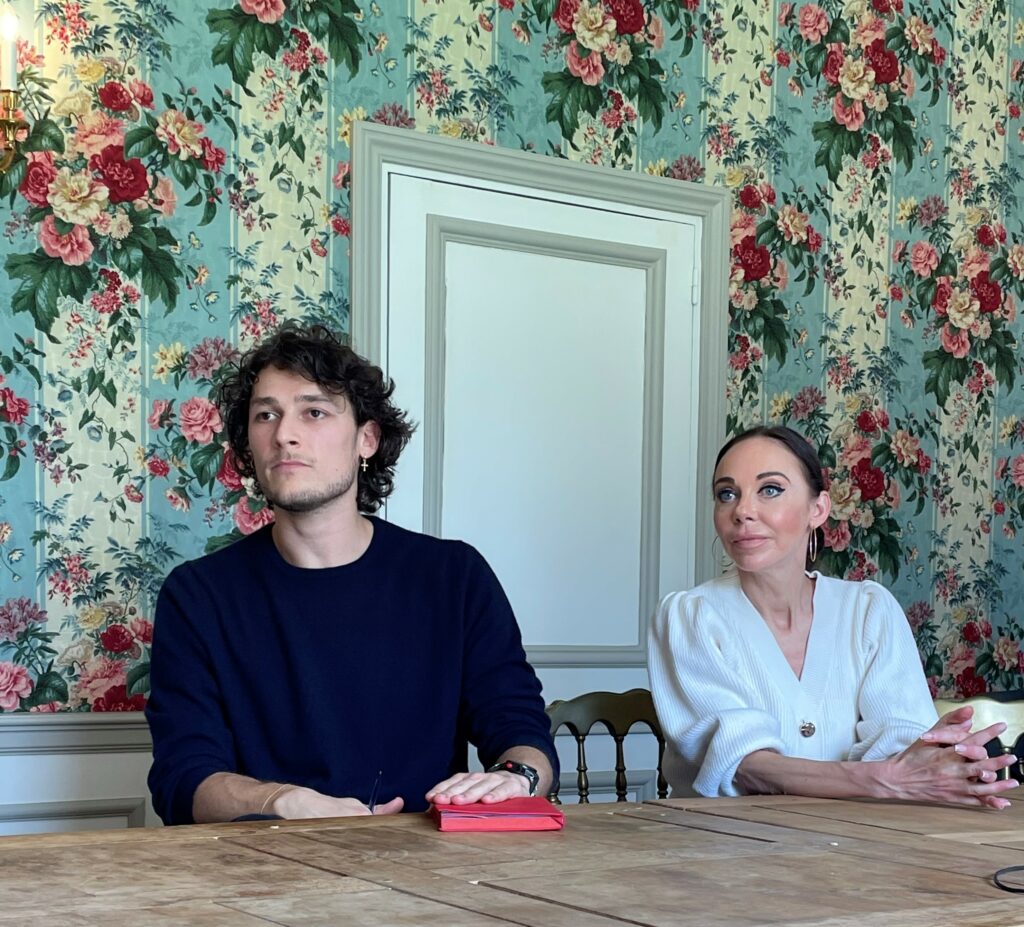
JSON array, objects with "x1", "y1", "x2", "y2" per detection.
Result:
[{"x1": 714, "y1": 437, "x2": 829, "y2": 573}]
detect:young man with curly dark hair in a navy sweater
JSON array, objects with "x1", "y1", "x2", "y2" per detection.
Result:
[{"x1": 146, "y1": 325, "x2": 557, "y2": 824}]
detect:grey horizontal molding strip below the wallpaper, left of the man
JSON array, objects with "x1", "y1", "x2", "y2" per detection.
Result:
[{"x1": 0, "y1": 712, "x2": 153, "y2": 756}]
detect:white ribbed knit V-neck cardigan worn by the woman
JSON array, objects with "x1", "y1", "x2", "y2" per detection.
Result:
[{"x1": 648, "y1": 573, "x2": 936, "y2": 797}]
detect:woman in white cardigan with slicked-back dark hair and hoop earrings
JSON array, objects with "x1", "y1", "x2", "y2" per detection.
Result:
[{"x1": 649, "y1": 427, "x2": 1018, "y2": 808}]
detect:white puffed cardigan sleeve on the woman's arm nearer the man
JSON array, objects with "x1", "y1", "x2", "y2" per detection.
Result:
[{"x1": 648, "y1": 592, "x2": 784, "y2": 798}]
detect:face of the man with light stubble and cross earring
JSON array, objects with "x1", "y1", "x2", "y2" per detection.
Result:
[{"x1": 249, "y1": 367, "x2": 379, "y2": 512}]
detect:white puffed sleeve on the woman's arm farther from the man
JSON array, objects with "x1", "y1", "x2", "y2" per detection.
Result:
[{"x1": 850, "y1": 582, "x2": 937, "y2": 760}]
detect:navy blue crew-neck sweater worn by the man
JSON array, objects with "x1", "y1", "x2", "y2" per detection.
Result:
[{"x1": 146, "y1": 518, "x2": 558, "y2": 824}]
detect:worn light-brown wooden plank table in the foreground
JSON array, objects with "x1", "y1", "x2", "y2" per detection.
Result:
[{"x1": 0, "y1": 797, "x2": 1024, "y2": 927}]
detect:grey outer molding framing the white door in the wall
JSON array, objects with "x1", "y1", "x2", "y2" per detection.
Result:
[{"x1": 350, "y1": 122, "x2": 732, "y2": 667}]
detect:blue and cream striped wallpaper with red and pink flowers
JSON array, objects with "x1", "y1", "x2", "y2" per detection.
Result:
[{"x1": 0, "y1": 0, "x2": 1024, "y2": 712}]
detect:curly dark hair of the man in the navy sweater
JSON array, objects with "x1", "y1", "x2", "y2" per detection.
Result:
[{"x1": 216, "y1": 322, "x2": 416, "y2": 512}]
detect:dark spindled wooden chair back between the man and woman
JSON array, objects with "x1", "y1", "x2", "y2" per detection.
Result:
[{"x1": 547, "y1": 688, "x2": 669, "y2": 805}]
